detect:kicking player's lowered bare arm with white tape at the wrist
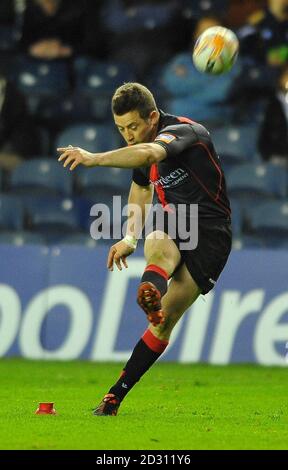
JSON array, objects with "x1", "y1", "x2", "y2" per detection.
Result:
[{"x1": 107, "y1": 181, "x2": 154, "y2": 271}]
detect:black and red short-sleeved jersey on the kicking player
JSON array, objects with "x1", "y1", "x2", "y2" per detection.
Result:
[{"x1": 133, "y1": 111, "x2": 231, "y2": 220}]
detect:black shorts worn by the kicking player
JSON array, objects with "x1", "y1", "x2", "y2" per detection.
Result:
[{"x1": 146, "y1": 208, "x2": 232, "y2": 294}]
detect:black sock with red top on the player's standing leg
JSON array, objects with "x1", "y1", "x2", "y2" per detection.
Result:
[{"x1": 109, "y1": 330, "x2": 168, "y2": 401}]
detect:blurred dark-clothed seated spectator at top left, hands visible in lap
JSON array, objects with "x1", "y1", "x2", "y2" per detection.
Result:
[{"x1": 21, "y1": 0, "x2": 84, "y2": 60}]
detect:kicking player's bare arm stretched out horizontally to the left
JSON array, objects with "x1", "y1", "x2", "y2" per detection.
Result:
[{"x1": 57, "y1": 143, "x2": 167, "y2": 170}]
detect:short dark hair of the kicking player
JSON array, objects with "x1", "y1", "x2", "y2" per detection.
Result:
[{"x1": 112, "y1": 82, "x2": 157, "y2": 119}]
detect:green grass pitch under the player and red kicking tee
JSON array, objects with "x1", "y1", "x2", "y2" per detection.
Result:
[{"x1": 0, "y1": 359, "x2": 288, "y2": 450}]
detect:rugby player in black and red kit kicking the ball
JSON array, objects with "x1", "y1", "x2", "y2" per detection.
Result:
[{"x1": 58, "y1": 83, "x2": 231, "y2": 415}]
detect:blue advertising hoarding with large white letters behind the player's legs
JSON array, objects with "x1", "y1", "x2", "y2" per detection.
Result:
[{"x1": 0, "y1": 246, "x2": 288, "y2": 366}]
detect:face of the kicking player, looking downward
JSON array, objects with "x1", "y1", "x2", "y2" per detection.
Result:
[{"x1": 114, "y1": 110, "x2": 159, "y2": 145}]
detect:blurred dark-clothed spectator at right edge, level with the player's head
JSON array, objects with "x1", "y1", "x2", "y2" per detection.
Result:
[{"x1": 259, "y1": 66, "x2": 288, "y2": 165}]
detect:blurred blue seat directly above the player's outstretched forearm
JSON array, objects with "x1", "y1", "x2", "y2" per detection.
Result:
[{"x1": 55, "y1": 123, "x2": 119, "y2": 153}]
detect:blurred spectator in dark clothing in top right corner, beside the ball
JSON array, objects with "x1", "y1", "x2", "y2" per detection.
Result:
[{"x1": 231, "y1": 0, "x2": 288, "y2": 115}]
